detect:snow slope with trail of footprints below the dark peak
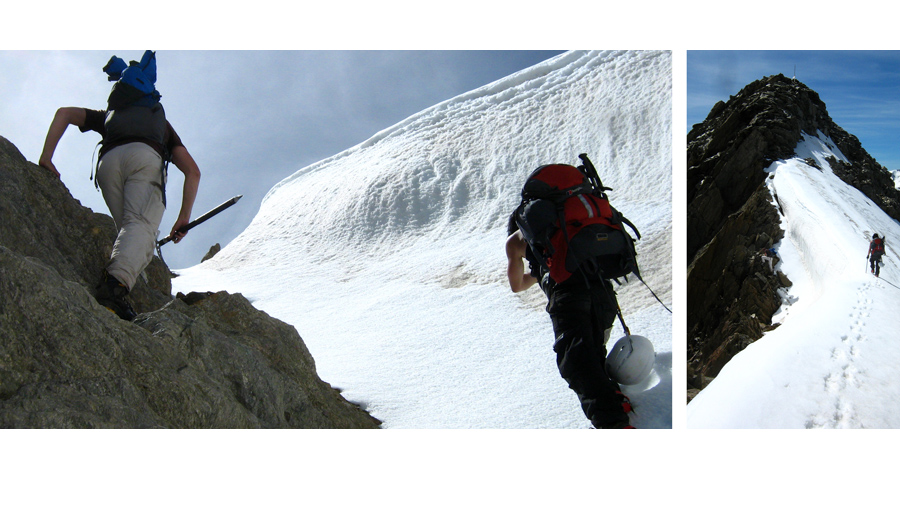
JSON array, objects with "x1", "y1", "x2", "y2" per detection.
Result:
[{"x1": 687, "y1": 133, "x2": 900, "y2": 428}]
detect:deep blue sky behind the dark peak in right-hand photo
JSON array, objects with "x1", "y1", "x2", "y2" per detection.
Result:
[{"x1": 687, "y1": 51, "x2": 900, "y2": 170}]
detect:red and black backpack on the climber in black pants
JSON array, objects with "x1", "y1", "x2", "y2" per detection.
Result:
[{"x1": 513, "y1": 154, "x2": 641, "y2": 283}]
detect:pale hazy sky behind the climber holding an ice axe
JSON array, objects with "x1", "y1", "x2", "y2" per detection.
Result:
[{"x1": 0, "y1": 50, "x2": 560, "y2": 268}]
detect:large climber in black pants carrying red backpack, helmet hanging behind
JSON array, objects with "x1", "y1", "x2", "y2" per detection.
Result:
[{"x1": 506, "y1": 154, "x2": 655, "y2": 428}]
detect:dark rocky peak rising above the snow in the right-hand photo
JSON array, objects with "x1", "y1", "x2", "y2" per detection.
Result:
[{"x1": 687, "y1": 75, "x2": 900, "y2": 397}]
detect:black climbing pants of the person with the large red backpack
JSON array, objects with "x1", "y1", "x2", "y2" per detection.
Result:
[{"x1": 547, "y1": 272, "x2": 628, "y2": 428}]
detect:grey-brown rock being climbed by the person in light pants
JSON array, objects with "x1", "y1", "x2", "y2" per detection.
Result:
[{"x1": 0, "y1": 134, "x2": 380, "y2": 428}]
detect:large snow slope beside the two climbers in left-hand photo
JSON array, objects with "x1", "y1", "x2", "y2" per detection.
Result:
[{"x1": 173, "y1": 51, "x2": 672, "y2": 428}]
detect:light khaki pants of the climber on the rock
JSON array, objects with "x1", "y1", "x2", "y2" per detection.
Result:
[{"x1": 97, "y1": 142, "x2": 166, "y2": 290}]
